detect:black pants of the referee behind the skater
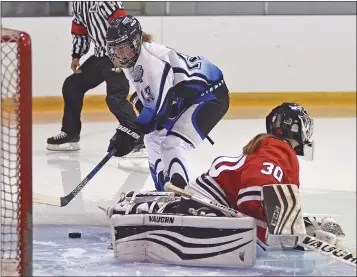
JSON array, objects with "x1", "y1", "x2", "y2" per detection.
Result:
[{"x1": 61, "y1": 56, "x2": 136, "y2": 136}]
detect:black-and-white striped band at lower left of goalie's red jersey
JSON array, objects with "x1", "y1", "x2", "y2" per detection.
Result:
[{"x1": 191, "y1": 174, "x2": 232, "y2": 207}]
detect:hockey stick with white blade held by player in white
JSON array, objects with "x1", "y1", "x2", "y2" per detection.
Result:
[{"x1": 33, "y1": 148, "x2": 116, "y2": 207}]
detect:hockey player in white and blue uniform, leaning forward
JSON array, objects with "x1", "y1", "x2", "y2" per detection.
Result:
[{"x1": 107, "y1": 16, "x2": 229, "y2": 191}]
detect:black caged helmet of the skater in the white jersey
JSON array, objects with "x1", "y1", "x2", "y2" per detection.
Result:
[{"x1": 106, "y1": 15, "x2": 143, "y2": 68}]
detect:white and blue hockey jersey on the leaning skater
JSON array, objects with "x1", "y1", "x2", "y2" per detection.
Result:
[{"x1": 123, "y1": 42, "x2": 223, "y2": 131}]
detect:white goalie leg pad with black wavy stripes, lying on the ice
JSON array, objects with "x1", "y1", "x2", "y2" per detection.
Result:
[{"x1": 111, "y1": 214, "x2": 256, "y2": 268}]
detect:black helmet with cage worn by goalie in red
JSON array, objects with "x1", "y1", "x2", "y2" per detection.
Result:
[{"x1": 266, "y1": 103, "x2": 314, "y2": 161}]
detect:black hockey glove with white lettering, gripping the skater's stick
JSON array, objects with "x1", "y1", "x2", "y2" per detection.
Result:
[{"x1": 108, "y1": 122, "x2": 142, "y2": 157}]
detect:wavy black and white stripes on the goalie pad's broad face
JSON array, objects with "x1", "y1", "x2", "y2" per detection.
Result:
[{"x1": 115, "y1": 223, "x2": 253, "y2": 260}]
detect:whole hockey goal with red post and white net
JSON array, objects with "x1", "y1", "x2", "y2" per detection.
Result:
[{"x1": 0, "y1": 28, "x2": 32, "y2": 276}]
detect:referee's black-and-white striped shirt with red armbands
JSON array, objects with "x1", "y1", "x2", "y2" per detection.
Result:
[{"x1": 71, "y1": 1, "x2": 127, "y2": 58}]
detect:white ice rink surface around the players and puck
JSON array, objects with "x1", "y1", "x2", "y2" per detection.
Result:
[{"x1": 33, "y1": 118, "x2": 356, "y2": 276}]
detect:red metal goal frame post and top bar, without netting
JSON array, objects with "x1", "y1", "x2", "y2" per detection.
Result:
[{"x1": 0, "y1": 28, "x2": 33, "y2": 276}]
